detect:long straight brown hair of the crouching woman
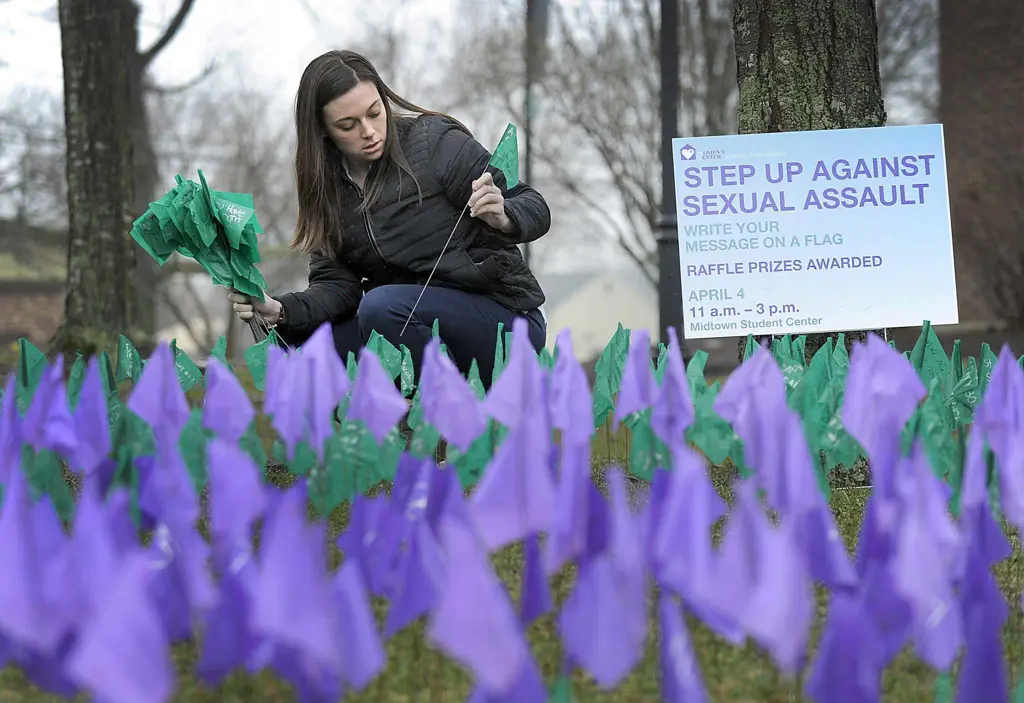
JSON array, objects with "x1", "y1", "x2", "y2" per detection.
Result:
[{"x1": 292, "y1": 51, "x2": 469, "y2": 256}]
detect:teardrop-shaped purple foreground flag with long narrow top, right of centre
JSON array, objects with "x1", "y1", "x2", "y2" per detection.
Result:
[{"x1": 558, "y1": 471, "x2": 647, "y2": 691}]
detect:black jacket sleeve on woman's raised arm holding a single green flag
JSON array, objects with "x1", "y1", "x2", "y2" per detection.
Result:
[{"x1": 431, "y1": 118, "x2": 551, "y2": 244}]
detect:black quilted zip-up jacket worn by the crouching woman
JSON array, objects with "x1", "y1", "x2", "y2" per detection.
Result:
[{"x1": 278, "y1": 116, "x2": 551, "y2": 337}]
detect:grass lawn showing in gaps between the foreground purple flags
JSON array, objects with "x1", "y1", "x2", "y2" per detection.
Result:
[{"x1": 0, "y1": 366, "x2": 1024, "y2": 703}]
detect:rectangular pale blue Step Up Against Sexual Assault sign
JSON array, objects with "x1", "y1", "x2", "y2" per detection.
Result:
[{"x1": 672, "y1": 125, "x2": 958, "y2": 339}]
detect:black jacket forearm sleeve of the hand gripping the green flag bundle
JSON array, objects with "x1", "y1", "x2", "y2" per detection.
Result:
[{"x1": 278, "y1": 254, "x2": 362, "y2": 340}]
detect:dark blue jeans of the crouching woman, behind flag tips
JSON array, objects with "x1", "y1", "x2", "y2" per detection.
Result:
[{"x1": 288, "y1": 284, "x2": 548, "y2": 388}]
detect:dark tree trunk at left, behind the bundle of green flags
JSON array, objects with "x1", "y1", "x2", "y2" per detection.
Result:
[{"x1": 52, "y1": 0, "x2": 138, "y2": 355}]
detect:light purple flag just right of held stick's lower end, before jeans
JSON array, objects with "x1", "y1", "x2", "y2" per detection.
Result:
[{"x1": 421, "y1": 337, "x2": 487, "y2": 451}]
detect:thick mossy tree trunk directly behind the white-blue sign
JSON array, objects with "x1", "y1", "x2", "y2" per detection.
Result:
[{"x1": 732, "y1": 0, "x2": 886, "y2": 360}]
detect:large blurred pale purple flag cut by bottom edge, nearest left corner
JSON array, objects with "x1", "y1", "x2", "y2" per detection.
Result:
[{"x1": 67, "y1": 552, "x2": 175, "y2": 703}]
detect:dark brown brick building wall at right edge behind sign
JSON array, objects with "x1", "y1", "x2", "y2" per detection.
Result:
[{"x1": 939, "y1": 0, "x2": 1024, "y2": 322}]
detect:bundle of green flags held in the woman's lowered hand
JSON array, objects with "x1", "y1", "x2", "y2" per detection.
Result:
[{"x1": 131, "y1": 170, "x2": 266, "y2": 301}]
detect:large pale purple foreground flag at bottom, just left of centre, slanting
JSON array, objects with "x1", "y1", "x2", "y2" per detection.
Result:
[{"x1": 427, "y1": 482, "x2": 529, "y2": 694}]
